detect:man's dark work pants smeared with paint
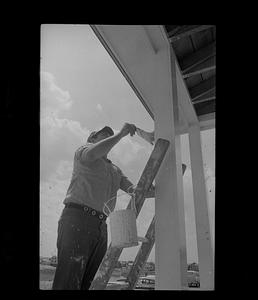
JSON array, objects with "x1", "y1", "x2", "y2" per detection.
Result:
[{"x1": 52, "y1": 208, "x2": 107, "y2": 290}]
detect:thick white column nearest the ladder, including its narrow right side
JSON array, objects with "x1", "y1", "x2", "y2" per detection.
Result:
[{"x1": 155, "y1": 46, "x2": 187, "y2": 290}]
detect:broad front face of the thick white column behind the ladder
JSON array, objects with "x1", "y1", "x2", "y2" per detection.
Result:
[{"x1": 154, "y1": 48, "x2": 183, "y2": 290}]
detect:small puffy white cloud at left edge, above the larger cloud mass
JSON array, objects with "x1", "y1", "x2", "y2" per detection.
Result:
[{"x1": 40, "y1": 72, "x2": 73, "y2": 116}]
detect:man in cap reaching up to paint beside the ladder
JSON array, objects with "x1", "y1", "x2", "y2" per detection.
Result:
[{"x1": 52, "y1": 123, "x2": 154, "y2": 290}]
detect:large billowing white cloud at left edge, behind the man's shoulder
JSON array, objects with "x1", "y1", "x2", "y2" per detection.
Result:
[{"x1": 40, "y1": 72, "x2": 90, "y2": 180}]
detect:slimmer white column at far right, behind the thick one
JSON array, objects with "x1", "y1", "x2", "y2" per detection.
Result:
[{"x1": 189, "y1": 125, "x2": 214, "y2": 290}]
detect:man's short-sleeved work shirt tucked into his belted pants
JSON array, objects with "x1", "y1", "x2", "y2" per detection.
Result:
[{"x1": 63, "y1": 143, "x2": 131, "y2": 213}]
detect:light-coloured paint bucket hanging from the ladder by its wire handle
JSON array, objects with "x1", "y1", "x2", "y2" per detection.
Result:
[{"x1": 103, "y1": 192, "x2": 138, "y2": 248}]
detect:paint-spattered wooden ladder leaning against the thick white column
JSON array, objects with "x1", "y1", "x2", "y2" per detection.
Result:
[{"x1": 90, "y1": 139, "x2": 170, "y2": 290}]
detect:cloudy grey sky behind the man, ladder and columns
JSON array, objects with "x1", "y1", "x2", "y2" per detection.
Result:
[{"x1": 40, "y1": 24, "x2": 215, "y2": 263}]
